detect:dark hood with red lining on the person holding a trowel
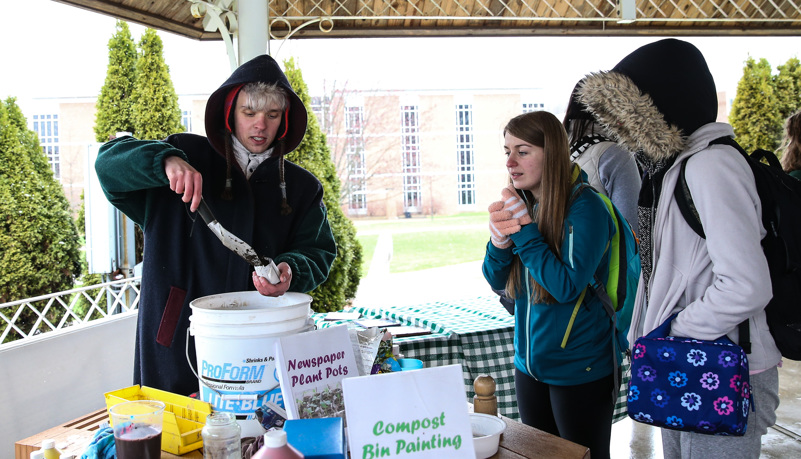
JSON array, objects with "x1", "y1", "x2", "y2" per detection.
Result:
[{"x1": 206, "y1": 54, "x2": 308, "y2": 155}]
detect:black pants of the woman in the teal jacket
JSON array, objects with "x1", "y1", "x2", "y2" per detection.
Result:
[{"x1": 515, "y1": 369, "x2": 615, "y2": 459}]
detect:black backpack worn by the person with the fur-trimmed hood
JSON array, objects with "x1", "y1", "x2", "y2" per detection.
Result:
[{"x1": 673, "y1": 137, "x2": 801, "y2": 360}]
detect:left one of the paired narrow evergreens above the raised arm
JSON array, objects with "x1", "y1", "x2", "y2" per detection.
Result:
[{"x1": 95, "y1": 21, "x2": 136, "y2": 142}]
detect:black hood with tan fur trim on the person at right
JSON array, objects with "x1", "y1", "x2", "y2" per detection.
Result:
[{"x1": 579, "y1": 38, "x2": 718, "y2": 160}]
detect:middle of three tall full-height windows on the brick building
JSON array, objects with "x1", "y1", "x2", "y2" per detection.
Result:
[{"x1": 401, "y1": 105, "x2": 423, "y2": 212}]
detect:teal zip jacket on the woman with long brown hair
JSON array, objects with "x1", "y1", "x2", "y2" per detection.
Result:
[{"x1": 482, "y1": 189, "x2": 615, "y2": 386}]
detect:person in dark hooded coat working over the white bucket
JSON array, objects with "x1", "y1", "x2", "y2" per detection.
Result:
[{"x1": 95, "y1": 55, "x2": 336, "y2": 395}]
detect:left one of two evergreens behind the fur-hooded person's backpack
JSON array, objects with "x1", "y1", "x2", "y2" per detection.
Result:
[{"x1": 729, "y1": 57, "x2": 782, "y2": 151}]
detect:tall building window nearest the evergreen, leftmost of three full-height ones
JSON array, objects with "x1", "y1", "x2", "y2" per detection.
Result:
[{"x1": 345, "y1": 106, "x2": 367, "y2": 213}]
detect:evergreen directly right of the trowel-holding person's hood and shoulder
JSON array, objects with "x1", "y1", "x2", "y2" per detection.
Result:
[{"x1": 284, "y1": 59, "x2": 362, "y2": 312}]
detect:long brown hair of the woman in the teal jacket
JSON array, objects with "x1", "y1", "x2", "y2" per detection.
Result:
[{"x1": 503, "y1": 111, "x2": 572, "y2": 303}]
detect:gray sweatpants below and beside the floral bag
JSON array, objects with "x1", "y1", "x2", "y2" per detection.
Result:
[{"x1": 661, "y1": 367, "x2": 779, "y2": 459}]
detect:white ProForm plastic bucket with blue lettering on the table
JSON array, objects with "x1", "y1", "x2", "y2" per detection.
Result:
[{"x1": 187, "y1": 291, "x2": 314, "y2": 420}]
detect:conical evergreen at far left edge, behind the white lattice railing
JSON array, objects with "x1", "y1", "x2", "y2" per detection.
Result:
[{"x1": 0, "y1": 98, "x2": 81, "y2": 339}]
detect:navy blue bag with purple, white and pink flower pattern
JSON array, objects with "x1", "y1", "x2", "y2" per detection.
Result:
[{"x1": 627, "y1": 314, "x2": 753, "y2": 436}]
